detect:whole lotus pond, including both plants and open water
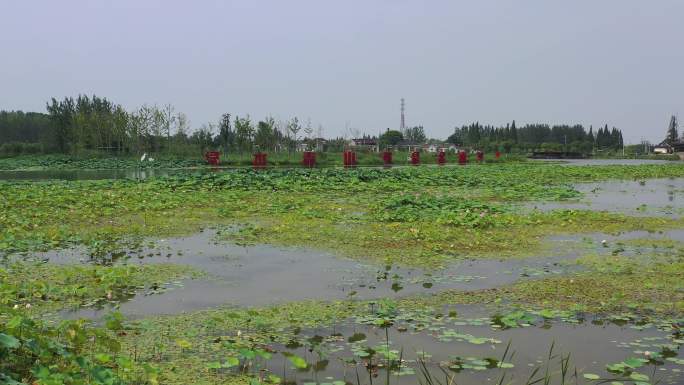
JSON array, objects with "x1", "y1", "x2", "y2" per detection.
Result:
[{"x1": 0, "y1": 162, "x2": 684, "y2": 385}]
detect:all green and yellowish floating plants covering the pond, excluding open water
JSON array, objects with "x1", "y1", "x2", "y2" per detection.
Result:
[{"x1": 0, "y1": 160, "x2": 684, "y2": 385}]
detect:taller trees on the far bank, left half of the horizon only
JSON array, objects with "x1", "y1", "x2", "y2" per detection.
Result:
[{"x1": 0, "y1": 95, "x2": 345, "y2": 155}]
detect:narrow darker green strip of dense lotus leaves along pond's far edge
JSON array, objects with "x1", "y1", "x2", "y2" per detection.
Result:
[{"x1": 149, "y1": 163, "x2": 684, "y2": 194}]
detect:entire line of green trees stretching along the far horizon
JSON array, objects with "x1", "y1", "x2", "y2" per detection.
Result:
[{"x1": 0, "y1": 95, "x2": 623, "y2": 155}]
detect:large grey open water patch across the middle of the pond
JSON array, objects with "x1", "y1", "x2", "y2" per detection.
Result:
[{"x1": 29, "y1": 231, "x2": 578, "y2": 318}]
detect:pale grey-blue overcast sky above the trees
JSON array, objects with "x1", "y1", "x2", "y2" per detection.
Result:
[{"x1": 0, "y1": 0, "x2": 684, "y2": 142}]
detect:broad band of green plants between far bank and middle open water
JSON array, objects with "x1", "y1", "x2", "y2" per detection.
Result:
[{"x1": 0, "y1": 163, "x2": 684, "y2": 255}]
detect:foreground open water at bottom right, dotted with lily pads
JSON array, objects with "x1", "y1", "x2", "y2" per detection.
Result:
[{"x1": 207, "y1": 306, "x2": 684, "y2": 385}]
